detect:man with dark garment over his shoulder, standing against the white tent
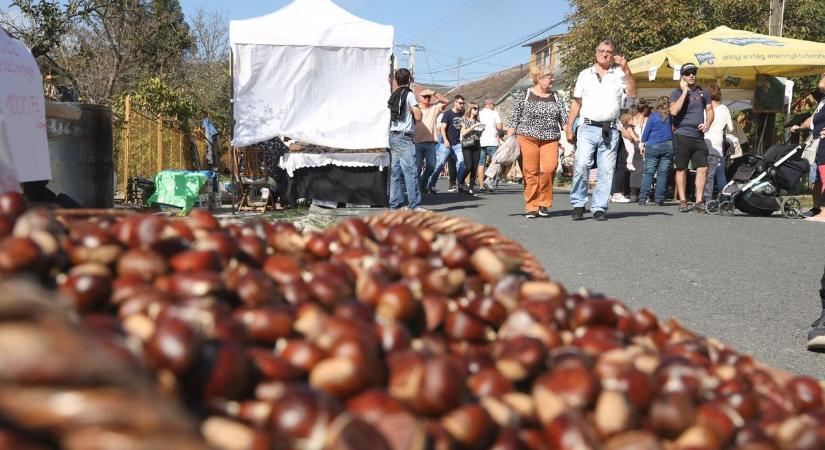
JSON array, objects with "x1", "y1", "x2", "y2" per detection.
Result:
[{"x1": 387, "y1": 68, "x2": 423, "y2": 211}]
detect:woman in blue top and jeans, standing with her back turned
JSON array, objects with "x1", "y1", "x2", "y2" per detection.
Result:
[{"x1": 639, "y1": 96, "x2": 674, "y2": 206}]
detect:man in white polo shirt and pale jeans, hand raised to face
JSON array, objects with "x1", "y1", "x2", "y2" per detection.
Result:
[{"x1": 565, "y1": 39, "x2": 636, "y2": 221}]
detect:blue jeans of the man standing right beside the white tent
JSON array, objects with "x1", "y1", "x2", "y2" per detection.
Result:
[{"x1": 390, "y1": 133, "x2": 421, "y2": 209}]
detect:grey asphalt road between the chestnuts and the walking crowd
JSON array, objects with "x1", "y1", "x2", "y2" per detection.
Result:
[{"x1": 423, "y1": 181, "x2": 825, "y2": 379}]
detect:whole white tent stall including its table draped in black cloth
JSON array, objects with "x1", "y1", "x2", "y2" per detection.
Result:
[{"x1": 225, "y1": 0, "x2": 393, "y2": 205}]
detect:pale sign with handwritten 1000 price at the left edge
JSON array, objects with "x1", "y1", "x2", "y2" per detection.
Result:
[{"x1": 0, "y1": 27, "x2": 52, "y2": 190}]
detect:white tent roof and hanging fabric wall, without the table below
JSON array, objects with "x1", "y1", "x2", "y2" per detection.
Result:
[{"x1": 229, "y1": 0, "x2": 393, "y2": 149}]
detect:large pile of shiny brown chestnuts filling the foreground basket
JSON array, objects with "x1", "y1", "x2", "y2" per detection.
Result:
[{"x1": 0, "y1": 190, "x2": 825, "y2": 450}]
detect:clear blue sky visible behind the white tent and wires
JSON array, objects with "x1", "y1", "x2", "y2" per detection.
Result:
[{"x1": 181, "y1": 0, "x2": 570, "y2": 85}]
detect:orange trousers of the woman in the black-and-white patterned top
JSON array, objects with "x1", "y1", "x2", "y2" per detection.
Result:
[{"x1": 518, "y1": 136, "x2": 559, "y2": 212}]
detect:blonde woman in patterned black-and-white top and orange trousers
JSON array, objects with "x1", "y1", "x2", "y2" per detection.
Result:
[{"x1": 507, "y1": 65, "x2": 567, "y2": 219}]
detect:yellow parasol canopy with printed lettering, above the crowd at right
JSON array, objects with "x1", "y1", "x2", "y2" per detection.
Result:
[{"x1": 629, "y1": 27, "x2": 825, "y2": 89}]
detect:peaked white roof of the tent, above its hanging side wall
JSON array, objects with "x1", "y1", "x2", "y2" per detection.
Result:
[{"x1": 229, "y1": 0, "x2": 393, "y2": 48}]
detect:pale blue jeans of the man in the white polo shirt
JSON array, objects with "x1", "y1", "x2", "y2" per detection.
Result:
[{"x1": 570, "y1": 125, "x2": 619, "y2": 212}]
